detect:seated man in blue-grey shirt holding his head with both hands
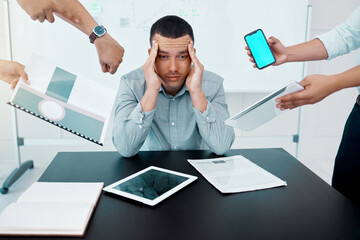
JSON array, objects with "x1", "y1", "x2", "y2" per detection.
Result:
[{"x1": 113, "y1": 16, "x2": 235, "y2": 157}]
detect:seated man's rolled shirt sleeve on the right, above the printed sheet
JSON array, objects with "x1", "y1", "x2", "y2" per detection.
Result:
[{"x1": 193, "y1": 84, "x2": 235, "y2": 155}]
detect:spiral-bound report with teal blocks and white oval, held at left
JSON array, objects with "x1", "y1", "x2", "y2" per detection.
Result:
[{"x1": 8, "y1": 54, "x2": 116, "y2": 146}]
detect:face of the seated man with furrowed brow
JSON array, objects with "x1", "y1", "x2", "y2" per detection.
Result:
[{"x1": 153, "y1": 34, "x2": 191, "y2": 94}]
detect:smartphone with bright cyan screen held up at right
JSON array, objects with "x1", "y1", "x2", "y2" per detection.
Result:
[{"x1": 244, "y1": 29, "x2": 276, "y2": 69}]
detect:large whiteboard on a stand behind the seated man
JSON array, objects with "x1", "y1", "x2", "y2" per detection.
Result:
[{"x1": 10, "y1": 0, "x2": 308, "y2": 92}]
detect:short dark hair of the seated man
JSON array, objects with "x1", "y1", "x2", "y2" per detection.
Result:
[{"x1": 150, "y1": 15, "x2": 194, "y2": 46}]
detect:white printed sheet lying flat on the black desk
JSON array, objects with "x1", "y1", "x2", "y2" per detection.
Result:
[{"x1": 188, "y1": 155, "x2": 286, "y2": 193}]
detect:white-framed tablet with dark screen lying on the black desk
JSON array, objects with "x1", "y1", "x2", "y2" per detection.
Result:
[{"x1": 104, "y1": 166, "x2": 197, "y2": 206}]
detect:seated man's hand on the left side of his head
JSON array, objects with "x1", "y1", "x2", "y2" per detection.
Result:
[{"x1": 142, "y1": 41, "x2": 161, "y2": 92}]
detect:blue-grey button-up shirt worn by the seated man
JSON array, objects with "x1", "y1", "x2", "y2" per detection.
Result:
[{"x1": 113, "y1": 67, "x2": 235, "y2": 157}]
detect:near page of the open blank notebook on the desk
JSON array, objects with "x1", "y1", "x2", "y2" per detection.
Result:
[{"x1": 0, "y1": 203, "x2": 93, "y2": 235}]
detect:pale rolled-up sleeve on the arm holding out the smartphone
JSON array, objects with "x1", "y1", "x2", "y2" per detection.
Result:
[{"x1": 317, "y1": 7, "x2": 360, "y2": 93}]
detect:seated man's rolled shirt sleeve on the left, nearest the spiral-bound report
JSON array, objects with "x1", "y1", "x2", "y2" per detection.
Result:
[{"x1": 112, "y1": 77, "x2": 155, "y2": 157}]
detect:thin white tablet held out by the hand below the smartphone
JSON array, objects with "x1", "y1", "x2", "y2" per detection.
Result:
[{"x1": 225, "y1": 82, "x2": 304, "y2": 131}]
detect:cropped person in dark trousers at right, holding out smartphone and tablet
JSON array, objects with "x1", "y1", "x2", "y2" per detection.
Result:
[{"x1": 246, "y1": 8, "x2": 360, "y2": 205}]
